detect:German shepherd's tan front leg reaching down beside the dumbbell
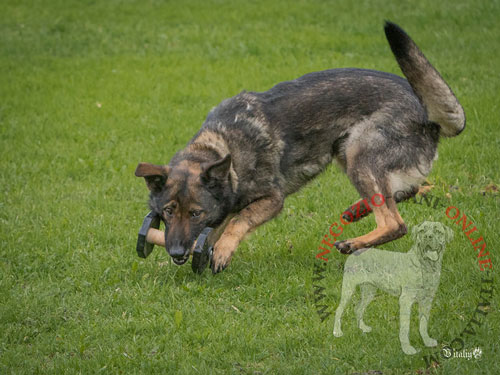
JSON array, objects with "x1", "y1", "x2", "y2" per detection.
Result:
[{"x1": 212, "y1": 194, "x2": 283, "y2": 274}]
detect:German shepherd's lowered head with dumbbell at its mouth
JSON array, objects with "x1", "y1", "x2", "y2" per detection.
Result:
[{"x1": 135, "y1": 155, "x2": 232, "y2": 265}]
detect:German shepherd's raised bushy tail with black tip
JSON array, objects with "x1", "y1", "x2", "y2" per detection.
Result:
[{"x1": 384, "y1": 21, "x2": 465, "y2": 137}]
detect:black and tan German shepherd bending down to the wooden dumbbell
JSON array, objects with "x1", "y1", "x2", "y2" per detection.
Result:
[{"x1": 135, "y1": 22, "x2": 465, "y2": 273}]
